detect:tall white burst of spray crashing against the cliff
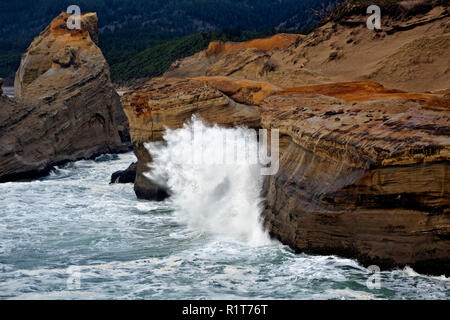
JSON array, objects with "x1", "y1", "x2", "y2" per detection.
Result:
[{"x1": 146, "y1": 118, "x2": 270, "y2": 245}]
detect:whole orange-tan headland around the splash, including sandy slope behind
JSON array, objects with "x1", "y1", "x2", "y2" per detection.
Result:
[{"x1": 122, "y1": 7, "x2": 450, "y2": 276}]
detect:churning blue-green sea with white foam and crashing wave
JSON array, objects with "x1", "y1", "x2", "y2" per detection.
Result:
[{"x1": 0, "y1": 119, "x2": 450, "y2": 299}]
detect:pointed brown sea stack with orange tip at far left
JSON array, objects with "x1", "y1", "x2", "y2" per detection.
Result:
[{"x1": 0, "y1": 13, "x2": 125, "y2": 181}]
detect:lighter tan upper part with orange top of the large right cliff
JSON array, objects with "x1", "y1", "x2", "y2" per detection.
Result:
[{"x1": 261, "y1": 82, "x2": 450, "y2": 168}]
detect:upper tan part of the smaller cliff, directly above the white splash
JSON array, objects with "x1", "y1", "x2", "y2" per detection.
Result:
[{"x1": 122, "y1": 78, "x2": 259, "y2": 143}]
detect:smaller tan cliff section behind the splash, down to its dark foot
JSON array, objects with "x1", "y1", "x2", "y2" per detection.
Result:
[{"x1": 122, "y1": 78, "x2": 264, "y2": 200}]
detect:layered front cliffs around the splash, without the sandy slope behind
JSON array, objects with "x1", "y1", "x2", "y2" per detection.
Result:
[{"x1": 123, "y1": 77, "x2": 450, "y2": 275}]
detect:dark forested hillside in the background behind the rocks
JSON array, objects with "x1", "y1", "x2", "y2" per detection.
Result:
[{"x1": 0, "y1": 0, "x2": 334, "y2": 81}]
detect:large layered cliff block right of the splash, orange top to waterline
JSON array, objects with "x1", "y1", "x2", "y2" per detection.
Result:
[{"x1": 261, "y1": 82, "x2": 450, "y2": 275}]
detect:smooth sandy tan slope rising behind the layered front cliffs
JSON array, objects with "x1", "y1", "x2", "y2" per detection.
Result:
[{"x1": 165, "y1": 6, "x2": 450, "y2": 93}]
